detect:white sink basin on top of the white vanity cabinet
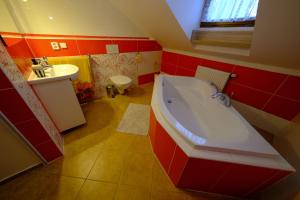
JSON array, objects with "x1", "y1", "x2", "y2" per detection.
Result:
[{"x1": 27, "y1": 64, "x2": 79, "y2": 85}]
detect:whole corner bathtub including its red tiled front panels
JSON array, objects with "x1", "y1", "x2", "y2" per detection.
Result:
[{"x1": 149, "y1": 74, "x2": 294, "y2": 196}]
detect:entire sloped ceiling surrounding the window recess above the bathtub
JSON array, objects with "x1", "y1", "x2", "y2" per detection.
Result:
[{"x1": 110, "y1": 0, "x2": 300, "y2": 69}]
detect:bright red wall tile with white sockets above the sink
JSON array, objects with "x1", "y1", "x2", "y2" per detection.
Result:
[{"x1": 26, "y1": 39, "x2": 79, "y2": 57}]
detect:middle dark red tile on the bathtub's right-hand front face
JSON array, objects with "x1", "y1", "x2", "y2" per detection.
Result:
[{"x1": 212, "y1": 164, "x2": 276, "y2": 197}]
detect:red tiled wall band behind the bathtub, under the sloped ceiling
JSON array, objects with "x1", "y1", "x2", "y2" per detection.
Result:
[{"x1": 161, "y1": 51, "x2": 300, "y2": 120}]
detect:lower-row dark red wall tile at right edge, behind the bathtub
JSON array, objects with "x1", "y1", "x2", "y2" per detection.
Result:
[{"x1": 264, "y1": 96, "x2": 300, "y2": 120}]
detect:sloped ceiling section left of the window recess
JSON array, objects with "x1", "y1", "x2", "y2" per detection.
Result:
[{"x1": 110, "y1": 0, "x2": 192, "y2": 50}]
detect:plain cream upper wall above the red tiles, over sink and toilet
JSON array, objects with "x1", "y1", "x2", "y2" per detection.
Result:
[{"x1": 2, "y1": 0, "x2": 147, "y2": 37}]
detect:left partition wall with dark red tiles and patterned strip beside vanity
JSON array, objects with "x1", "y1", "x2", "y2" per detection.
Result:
[{"x1": 0, "y1": 43, "x2": 63, "y2": 162}]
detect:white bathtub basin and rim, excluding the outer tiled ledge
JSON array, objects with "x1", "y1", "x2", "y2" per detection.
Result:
[{"x1": 158, "y1": 75, "x2": 278, "y2": 156}]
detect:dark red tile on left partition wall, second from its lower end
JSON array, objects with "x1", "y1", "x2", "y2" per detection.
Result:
[{"x1": 16, "y1": 119, "x2": 50, "y2": 145}]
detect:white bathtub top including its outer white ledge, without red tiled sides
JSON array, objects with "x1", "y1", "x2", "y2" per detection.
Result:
[{"x1": 151, "y1": 74, "x2": 293, "y2": 169}]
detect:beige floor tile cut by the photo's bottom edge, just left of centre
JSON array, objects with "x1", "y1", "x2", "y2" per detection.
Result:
[{"x1": 115, "y1": 185, "x2": 151, "y2": 200}]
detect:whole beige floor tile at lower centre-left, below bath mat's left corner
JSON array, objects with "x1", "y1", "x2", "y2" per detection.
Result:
[{"x1": 88, "y1": 149, "x2": 125, "y2": 183}]
